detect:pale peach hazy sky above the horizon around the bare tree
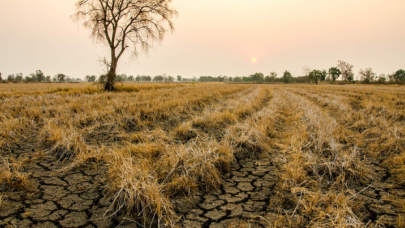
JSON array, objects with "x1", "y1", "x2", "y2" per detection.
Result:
[{"x1": 0, "y1": 0, "x2": 405, "y2": 78}]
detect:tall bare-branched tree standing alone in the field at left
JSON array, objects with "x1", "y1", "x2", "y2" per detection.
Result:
[{"x1": 75, "y1": 0, "x2": 178, "y2": 91}]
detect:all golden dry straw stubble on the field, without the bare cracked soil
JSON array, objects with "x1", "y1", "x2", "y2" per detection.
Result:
[{"x1": 0, "y1": 83, "x2": 405, "y2": 227}]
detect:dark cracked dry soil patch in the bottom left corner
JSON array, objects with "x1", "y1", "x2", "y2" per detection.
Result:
[{"x1": 0, "y1": 137, "x2": 137, "y2": 228}]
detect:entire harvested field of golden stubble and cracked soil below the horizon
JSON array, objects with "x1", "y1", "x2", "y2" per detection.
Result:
[{"x1": 0, "y1": 83, "x2": 405, "y2": 227}]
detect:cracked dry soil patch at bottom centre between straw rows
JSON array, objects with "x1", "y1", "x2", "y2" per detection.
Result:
[{"x1": 174, "y1": 153, "x2": 278, "y2": 228}]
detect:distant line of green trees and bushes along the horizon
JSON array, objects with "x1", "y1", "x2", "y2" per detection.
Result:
[{"x1": 0, "y1": 60, "x2": 405, "y2": 84}]
